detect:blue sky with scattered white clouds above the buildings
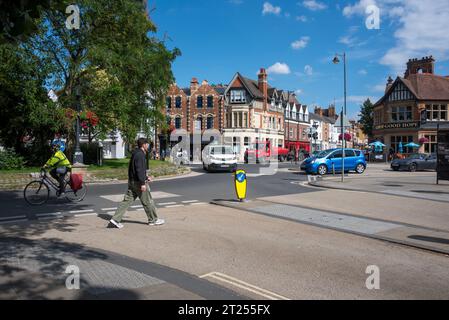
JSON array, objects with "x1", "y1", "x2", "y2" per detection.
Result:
[{"x1": 148, "y1": 0, "x2": 449, "y2": 117}]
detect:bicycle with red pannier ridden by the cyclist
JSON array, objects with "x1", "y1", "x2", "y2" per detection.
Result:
[{"x1": 23, "y1": 170, "x2": 87, "y2": 206}]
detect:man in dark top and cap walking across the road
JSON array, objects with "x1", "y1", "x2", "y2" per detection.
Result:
[{"x1": 110, "y1": 138, "x2": 165, "y2": 229}]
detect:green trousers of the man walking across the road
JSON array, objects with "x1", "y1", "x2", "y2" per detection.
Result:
[{"x1": 112, "y1": 181, "x2": 157, "y2": 223}]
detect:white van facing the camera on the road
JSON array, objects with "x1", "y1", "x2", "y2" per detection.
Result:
[{"x1": 202, "y1": 144, "x2": 237, "y2": 172}]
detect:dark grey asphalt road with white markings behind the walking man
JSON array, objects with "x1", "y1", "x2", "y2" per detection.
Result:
[{"x1": 0, "y1": 163, "x2": 319, "y2": 224}]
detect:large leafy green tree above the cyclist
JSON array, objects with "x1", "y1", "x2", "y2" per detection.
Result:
[{"x1": 0, "y1": 0, "x2": 180, "y2": 165}]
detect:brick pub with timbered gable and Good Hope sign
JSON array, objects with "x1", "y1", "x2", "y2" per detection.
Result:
[{"x1": 373, "y1": 57, "x2": 449, "y2": 153}]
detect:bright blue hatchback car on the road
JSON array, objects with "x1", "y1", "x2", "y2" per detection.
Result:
[{"x1": 301, "y1": 149, "x2": 366, "y2": 176}]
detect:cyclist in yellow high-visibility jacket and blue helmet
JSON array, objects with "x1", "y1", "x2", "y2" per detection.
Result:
[{"x1": 42, "y1": 140, "x2": 72, "y2": 196}]
